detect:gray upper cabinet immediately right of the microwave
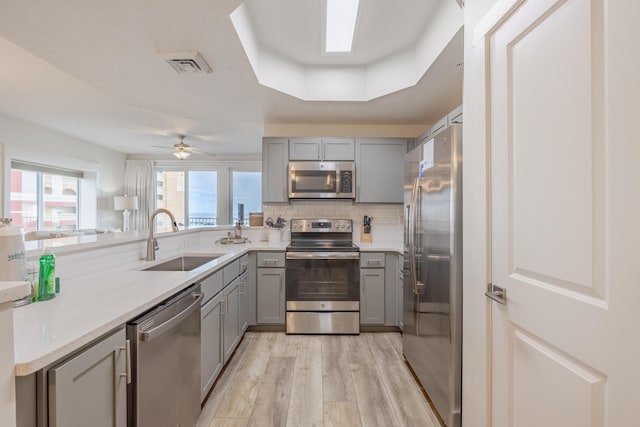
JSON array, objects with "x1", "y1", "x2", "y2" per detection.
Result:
[{"x1": 355, "y1": 138, "x2": 407, "y2": 203}]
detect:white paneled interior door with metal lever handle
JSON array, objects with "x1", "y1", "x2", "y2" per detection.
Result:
[{"x1": 482, "y1": 0, "x2": 640, "y2": 427}]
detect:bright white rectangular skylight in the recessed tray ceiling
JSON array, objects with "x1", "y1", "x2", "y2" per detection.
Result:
[{"x1": 324, "y1": 0, "x2": 360, "y2": 53}]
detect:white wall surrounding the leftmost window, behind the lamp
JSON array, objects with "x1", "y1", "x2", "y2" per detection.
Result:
[{"x1": 0, "y1": 114, "x2": 126, "y2": 228}]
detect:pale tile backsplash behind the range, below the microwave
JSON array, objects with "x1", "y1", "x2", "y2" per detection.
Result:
[{"x1": 262, "y1": 200, "x2": 404, "y2": 242}]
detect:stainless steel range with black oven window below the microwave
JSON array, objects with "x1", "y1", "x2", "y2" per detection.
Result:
[{"x1": 285, "y1": 219, "x2": 360, "y2": 334}]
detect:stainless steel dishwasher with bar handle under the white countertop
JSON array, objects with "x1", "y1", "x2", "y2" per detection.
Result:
[{"x1": 127, "y1": 284, "x2": 202, "y2": 427}]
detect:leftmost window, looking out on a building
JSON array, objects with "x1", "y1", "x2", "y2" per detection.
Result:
[{"x1": 10, "y1": 161, "x2": 82, "y2": 232}]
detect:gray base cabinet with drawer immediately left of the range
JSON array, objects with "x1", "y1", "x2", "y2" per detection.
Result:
[{"x1": 256, "y1": 252, "x2": 285, "y2": 325}]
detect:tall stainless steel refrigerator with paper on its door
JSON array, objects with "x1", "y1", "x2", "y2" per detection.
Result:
[{"x1": 402, "y1": 124, "x2": 462, "y2": 427}]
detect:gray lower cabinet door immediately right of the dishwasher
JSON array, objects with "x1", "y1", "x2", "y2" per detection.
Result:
[{"x1": 200, "y1": 293, "x2": 224, "y2": 403}]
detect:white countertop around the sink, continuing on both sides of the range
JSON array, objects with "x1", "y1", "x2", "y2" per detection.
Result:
[{"x1": 13, "y1": 236, "x2": 402, "y2": 376}]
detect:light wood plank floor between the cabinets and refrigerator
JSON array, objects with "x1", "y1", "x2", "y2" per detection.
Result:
[{"x1": 197, "y1": 332, "x2": 440, "y2": 427}]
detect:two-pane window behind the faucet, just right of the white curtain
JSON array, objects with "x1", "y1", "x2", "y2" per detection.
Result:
[{"x1": 156, "y1": 170, "x2": 218, "y2": 232}]
